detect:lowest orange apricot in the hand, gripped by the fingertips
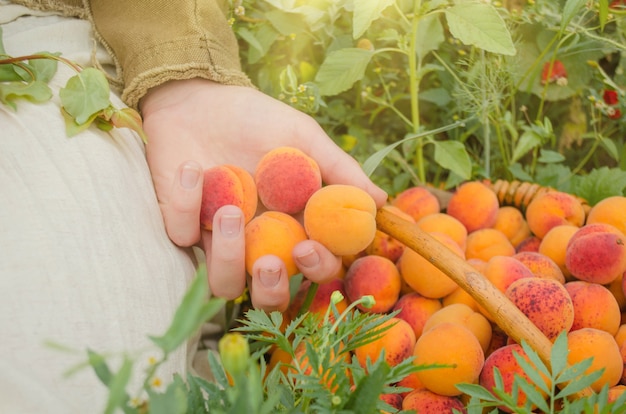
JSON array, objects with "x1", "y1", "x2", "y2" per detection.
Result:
[{"x1": 245, "y1": 211, "x2": 307, "y2": 276}]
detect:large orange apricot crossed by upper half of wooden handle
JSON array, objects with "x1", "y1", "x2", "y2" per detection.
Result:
[{"x1": 398, "y1": 233, "x2": 464, "y2": 299}]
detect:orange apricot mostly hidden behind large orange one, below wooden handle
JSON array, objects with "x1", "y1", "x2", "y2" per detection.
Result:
[{"x1": 424, "y1": 303, "x2": 491, "y2": 352}]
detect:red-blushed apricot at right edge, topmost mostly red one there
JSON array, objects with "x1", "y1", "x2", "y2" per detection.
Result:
[{"x1": 565, "y1": 223, "x2": 626, "y2": 285}]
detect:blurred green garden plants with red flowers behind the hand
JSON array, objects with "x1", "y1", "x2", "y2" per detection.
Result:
[{"x1": 231, "y1": 0, "x2": 626, "y2": 203}]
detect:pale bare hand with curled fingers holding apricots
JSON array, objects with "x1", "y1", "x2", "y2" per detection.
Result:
[{"x1": 141, "y1": 79, "x2": 387, "y2": 310}]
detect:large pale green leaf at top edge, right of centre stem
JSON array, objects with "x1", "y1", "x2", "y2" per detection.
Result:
[{"x1": 445, "y1": 2, "x2": 515, "y2": 56}]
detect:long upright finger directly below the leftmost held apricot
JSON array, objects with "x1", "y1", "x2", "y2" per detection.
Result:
[{"x1": 204, "y1": 205, "x2": 246, "y2": 299}]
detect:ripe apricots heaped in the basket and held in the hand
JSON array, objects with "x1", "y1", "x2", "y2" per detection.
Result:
[{"x1": 203, "y1": 148, "x2": 626, "y2": 412}]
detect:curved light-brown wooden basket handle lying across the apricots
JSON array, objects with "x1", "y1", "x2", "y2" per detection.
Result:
[{"x1": 376, "y1": 208, "x2": 552, "y2": 367}]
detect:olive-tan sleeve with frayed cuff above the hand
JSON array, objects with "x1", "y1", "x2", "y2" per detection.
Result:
[{"x1": 84, "y1": 0, "x2": 252, "y2": 108}]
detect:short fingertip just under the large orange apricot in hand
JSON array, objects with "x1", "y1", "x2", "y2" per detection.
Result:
[{"x1": 293, "y1": 240, "x2": 341, "y2": 283}]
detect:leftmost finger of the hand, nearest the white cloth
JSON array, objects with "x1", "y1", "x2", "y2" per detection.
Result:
[{"x1": 161, "y1": 161, "x2": 202, "y2": 247}]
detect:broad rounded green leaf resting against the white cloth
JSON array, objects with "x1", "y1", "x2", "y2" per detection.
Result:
[{"x1": 59, "y1": 68, "x2": 111, "y2": 125}]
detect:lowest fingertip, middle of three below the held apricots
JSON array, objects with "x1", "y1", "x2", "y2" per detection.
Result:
[{"x1": 250, "y1": 255, "x2": 289, "y2": 312}]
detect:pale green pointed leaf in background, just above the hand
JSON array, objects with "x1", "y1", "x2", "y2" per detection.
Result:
[{"x1": 315, "y1": 48, "x2": 374, "y2": 95}]
